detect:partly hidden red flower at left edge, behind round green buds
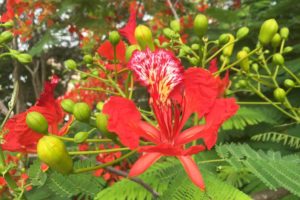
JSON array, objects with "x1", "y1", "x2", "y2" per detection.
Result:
[{"x1": 2, "y1": 77, "x2": 68, "y2": 152}]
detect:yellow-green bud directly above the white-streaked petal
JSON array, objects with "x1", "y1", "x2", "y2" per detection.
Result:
[{"x1": 134, "y1": 25, "x2": 154, "y2": 51}]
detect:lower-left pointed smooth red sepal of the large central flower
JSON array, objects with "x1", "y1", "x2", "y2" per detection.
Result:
[{"x1": 128, "y1": 153, "x2": 162, "y2": 177}]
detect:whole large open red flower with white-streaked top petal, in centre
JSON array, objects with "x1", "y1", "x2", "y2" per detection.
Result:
[{"x1": 103, "y1": 49, "x2": 238, "y2": 189}]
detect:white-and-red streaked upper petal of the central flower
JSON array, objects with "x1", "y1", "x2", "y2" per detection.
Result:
[{"x1": 128, "y1": 49, "x2": 183, "y2": 102}]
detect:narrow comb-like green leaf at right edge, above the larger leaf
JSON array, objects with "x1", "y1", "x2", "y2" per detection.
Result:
[{"x1": 251, "y1": 132, "x2": 300, "y2": 149}]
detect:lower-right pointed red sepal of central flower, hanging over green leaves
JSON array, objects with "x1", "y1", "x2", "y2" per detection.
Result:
[{"x1": 177, "y1": 156, "x2": 205, "y2": 190}]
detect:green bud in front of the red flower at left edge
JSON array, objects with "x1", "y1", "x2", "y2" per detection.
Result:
[{"x1": 26, "y1": 111, "x2": 48, "y2": 134}]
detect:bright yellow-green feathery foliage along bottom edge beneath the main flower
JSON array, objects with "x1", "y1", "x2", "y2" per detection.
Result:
[{"x1": 96, "y1": 159, "x2": 250, "y2": 200}]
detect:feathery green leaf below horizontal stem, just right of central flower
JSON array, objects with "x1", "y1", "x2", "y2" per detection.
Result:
[{"x1": 222, "y1": 106, "x2": 280, "y2": 130}]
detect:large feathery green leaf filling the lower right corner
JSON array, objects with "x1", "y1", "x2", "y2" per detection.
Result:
[{"x1": 216, "y1": 144, "x2": 300, "y2": 196}]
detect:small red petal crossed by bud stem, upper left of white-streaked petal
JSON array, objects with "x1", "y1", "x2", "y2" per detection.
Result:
[{"x1": 97, "y1": 40, "x2": 126, "y2": 63}]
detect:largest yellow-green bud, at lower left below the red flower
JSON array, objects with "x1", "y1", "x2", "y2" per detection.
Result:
[{"x1": 37, "y1": 136, "x2": 73, "y2": 174}]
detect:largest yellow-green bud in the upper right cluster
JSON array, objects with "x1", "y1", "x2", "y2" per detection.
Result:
[{"x1": 258, "y1": 19, "x2": 278, "y2": 46}]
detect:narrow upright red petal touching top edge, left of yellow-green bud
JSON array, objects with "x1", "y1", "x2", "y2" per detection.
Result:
[{"x1": 119, "y1": 1, "x2": 136, "y2": 44}]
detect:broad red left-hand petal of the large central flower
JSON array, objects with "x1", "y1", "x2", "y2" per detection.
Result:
[{"x1": 103, "y1": 97, "x2": 142, "y2": 149}]
